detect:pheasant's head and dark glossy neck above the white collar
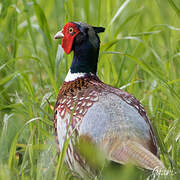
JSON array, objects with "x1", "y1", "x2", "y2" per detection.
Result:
[{"x1": 54, "y1": 22, "x2": 105, "y2": 74}]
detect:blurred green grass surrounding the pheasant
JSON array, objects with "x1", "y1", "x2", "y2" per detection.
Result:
[{"x1": 0, "y1": 0, "x2": 180, "y2": 179}]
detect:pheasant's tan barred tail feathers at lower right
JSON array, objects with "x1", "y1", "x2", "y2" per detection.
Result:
[{"x1": 105, "y1": 140, "x2": 164, "y2": 170}]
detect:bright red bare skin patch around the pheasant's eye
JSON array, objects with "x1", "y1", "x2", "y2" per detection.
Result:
[{"x1": 61, "y1": 23, "x2": 80, "y2": 54}]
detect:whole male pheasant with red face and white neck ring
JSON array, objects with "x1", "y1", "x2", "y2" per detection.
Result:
[{"x1": 54, "y1": 22, "x2": 164, "y2": 176}]
